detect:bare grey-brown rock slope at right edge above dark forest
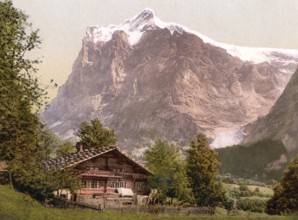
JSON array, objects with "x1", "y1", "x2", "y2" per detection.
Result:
[{"x1": 243, "y1": 70, "x2": 298, "y2": 155}]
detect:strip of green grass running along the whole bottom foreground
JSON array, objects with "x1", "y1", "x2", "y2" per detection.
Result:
[{"x1": 0, "y1": 185, "x2": 295, "y2": 220}]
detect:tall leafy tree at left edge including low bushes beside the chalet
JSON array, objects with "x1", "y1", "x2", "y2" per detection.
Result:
[{"x1": 0, "y1": 0, "x2": 79, "y2": 202}]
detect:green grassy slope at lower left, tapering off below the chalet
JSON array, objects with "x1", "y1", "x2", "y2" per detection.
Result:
[{"x1": 0, "y1": 185, "x2": 180, "y2": 220}]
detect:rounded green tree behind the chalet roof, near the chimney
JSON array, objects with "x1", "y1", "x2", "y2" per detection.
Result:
[{"x1": 78, "y1": 118, "x2": 116, "y2": 148}]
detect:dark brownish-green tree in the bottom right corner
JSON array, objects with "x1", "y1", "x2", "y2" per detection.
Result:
[{"x1": 266, "y1": 155, "x2": 298, "y2": 215}]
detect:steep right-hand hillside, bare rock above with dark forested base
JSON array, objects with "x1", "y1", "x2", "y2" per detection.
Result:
[{"x1": 214, "y1": 70, "x2": 298, "y2": 180}]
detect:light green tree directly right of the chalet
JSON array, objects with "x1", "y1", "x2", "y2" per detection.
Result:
[{"x1": 145, "y1": 139, "x2": 192, "y2": 204}]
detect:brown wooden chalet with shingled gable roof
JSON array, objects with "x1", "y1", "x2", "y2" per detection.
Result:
[{"x1": 43, "y1": 146, "x2": 152, "y2": 207}]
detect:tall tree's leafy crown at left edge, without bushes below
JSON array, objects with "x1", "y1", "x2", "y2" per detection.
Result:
[{"x1": 0, "y1": 1, "x2": 45, "y2": 173}]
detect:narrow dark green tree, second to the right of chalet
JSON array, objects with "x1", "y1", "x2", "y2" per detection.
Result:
[{"x1": 187, "y1": 134, "x2": 225, "y2": 207}]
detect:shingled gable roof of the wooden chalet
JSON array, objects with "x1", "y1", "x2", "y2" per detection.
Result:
[{"x1": 42, "y1": 147, "x2": 152, "y2": 174}]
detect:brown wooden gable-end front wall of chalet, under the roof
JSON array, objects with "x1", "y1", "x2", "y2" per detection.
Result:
[{"x1": 76, "y1": 149, "x2": 150, "y2": 196}]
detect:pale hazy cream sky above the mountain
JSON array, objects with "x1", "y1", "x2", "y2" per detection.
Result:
[{"x1": 13, "y1": 0, "x2": 298, "y2": 99}]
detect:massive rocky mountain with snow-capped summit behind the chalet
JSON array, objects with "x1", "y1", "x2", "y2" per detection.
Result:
[{"x1": 42, "y1": 9, "x2": 298, "y2": 153}]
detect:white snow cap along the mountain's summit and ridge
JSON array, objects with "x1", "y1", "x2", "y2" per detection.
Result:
[{"x1": 85, "y1": 8, "x2": 298, "y2": 64}]
